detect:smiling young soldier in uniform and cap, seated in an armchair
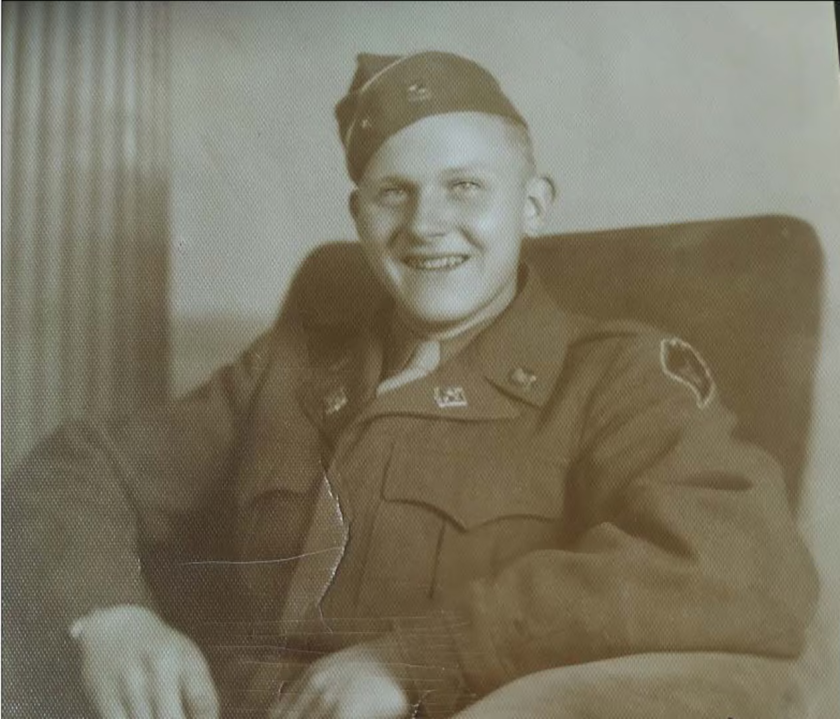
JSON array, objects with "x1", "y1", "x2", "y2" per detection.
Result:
[{"x1": 4, "y1": 52, "x2": 816, "y2": 719}]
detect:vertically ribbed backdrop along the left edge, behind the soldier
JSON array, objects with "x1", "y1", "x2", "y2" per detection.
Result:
[{"x1": 2, "y1": 2, "x2": 170, "y2": 470}]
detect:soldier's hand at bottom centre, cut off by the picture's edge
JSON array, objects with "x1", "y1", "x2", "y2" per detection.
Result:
[{"x1": 268, "y1": 644, "x2": 411, "y2": 719}]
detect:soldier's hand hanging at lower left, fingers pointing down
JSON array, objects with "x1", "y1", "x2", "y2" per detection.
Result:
[{"x1": 73, "y1": 606, "x2": 219, "y2": 719}]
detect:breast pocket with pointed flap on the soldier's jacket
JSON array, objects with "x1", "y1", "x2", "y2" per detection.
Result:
[{"x1": 383, "y1": 427, "x2": 568, "y2": 597}]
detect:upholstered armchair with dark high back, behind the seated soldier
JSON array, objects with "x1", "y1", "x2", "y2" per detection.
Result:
[{"x1": 270, "y1": 216, "x2": 822, "y2": 719}]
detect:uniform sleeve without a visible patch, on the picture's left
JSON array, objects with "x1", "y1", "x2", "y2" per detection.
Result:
[{"x1": 3, "y1": 335, "x2": 273, "y2": 708}]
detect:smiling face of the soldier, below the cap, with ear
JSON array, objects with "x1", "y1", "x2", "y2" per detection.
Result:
[{"x1": 350, "y1": 112, "x2": 552, "y2": 338}]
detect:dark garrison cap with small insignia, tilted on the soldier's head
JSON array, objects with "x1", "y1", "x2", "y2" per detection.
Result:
[{"x1": 335, "y1": 52, "x2": 528, "y2": 182}]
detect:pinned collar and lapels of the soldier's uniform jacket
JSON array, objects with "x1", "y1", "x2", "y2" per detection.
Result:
[{"x1": 298, "y1": 268, "x2": 573, "y2": 434}]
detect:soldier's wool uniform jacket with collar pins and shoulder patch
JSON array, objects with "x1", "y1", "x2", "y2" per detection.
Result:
[{"x1": 3, "y1": 272, "x2": 817, "y2": 713}]
